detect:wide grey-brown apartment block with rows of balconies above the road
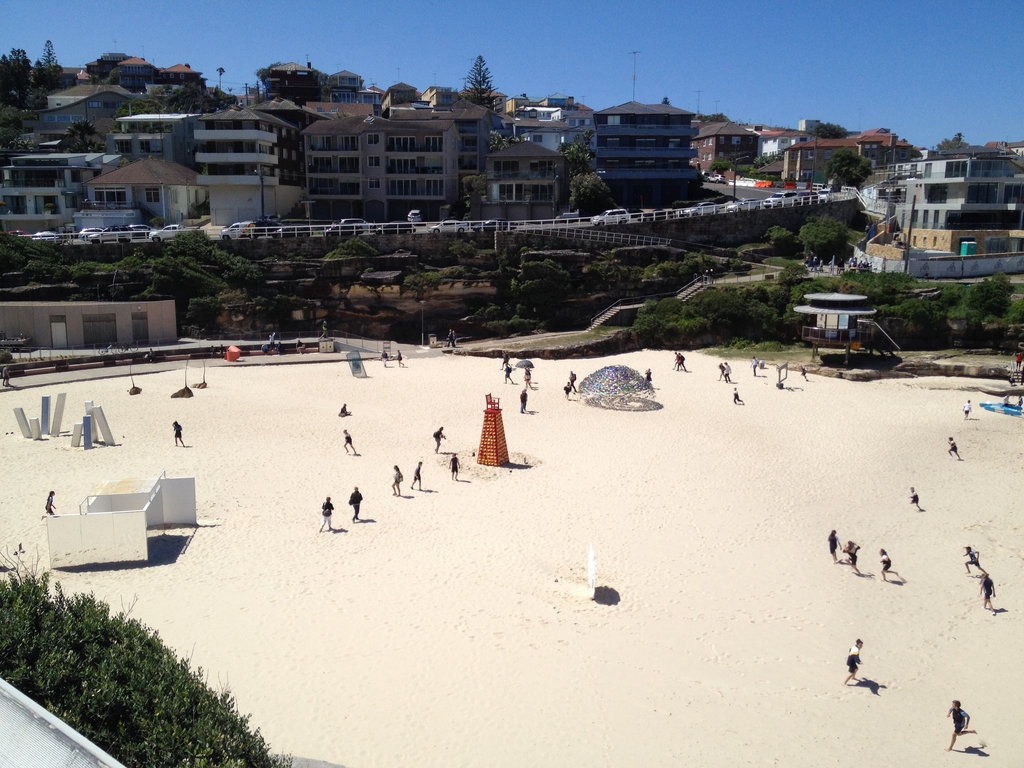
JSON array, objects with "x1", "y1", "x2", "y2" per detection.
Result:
[{"x1": 302, "y1": 117, "x2": 459, "y2": 221}]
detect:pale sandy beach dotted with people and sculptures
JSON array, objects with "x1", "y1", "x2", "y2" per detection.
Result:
[{"x1": 0, "y1": 350, "x2": 1024, "y2": 767}]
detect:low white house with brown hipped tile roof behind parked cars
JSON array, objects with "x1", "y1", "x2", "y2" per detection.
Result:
[{"x1": 82, "y1": 158, "x2": 209, "y2": 229}]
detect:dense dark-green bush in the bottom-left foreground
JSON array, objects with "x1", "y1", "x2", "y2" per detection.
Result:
[{"x1": 0, "y1": 573, "x2": 291, "y2": 768}]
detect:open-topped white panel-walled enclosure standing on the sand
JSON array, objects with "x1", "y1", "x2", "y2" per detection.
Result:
[{"x1": 46, "y1": 473, "x2": 197, "y2": 568}]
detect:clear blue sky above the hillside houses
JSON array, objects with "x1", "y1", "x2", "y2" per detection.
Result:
[{"x1": 0, "y1": 0, "x2": 1024, "y2": 147}]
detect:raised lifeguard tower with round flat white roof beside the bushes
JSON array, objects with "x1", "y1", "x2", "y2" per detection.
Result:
[{"x1": 793, "y1": 293, "x2": 899, "y2": 362}]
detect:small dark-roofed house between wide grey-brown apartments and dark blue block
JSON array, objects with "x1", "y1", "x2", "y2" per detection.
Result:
[{"x1": 479, "y1": 141, "x2": 568, "y2": 220}]
